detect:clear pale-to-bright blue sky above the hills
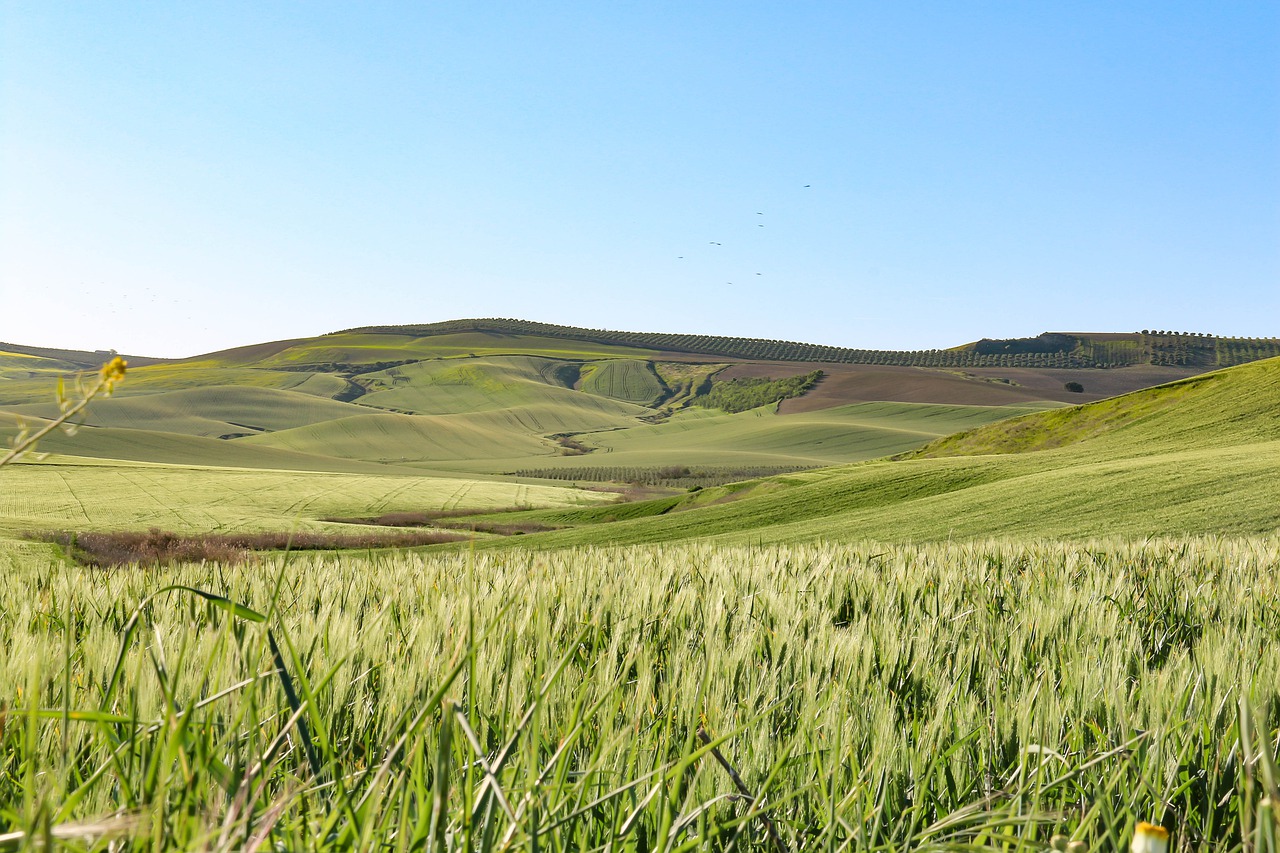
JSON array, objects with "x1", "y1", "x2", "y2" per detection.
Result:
[{"x1": 0, "y1": 0, "x2": 1280, "y2": 357}]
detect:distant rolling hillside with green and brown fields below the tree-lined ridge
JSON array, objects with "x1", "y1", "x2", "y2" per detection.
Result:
[{"x1": 0, "y1": 321, "x2": 1111, "y2": 482}]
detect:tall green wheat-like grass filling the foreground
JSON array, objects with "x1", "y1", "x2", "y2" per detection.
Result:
[{"x1": 0, "y1": 538, "x2": 1280, "y2": 850}]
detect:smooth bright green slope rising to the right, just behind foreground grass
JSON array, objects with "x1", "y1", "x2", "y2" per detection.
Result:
[{"x1": 465, "y1": 360, "x2": 1280, "y2": 546}]
